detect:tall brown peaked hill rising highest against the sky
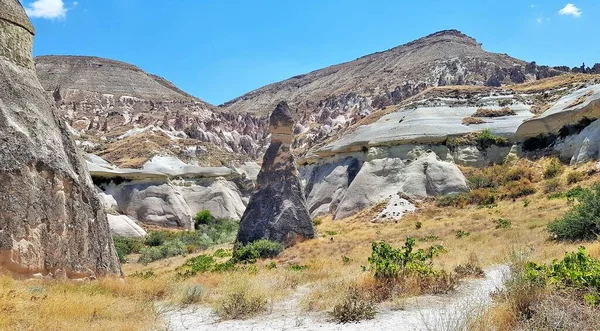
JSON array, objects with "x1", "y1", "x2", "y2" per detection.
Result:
[{"x1": 220, "y1": 30, "x2": 558, "y2": 156}]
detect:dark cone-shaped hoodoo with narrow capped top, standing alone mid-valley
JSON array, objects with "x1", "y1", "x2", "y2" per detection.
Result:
[{"x1": 237, "y1": 102, "x2": 315, "y2": 245}]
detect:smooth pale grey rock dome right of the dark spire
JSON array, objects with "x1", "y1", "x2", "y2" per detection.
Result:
[{"x1": 335, "y1": 151, "x2": 469, "y2": 219}]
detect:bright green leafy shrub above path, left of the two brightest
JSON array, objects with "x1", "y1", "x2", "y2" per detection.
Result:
[{"x1": 368, "y1": 237, "x2": 444, "y2": 279}]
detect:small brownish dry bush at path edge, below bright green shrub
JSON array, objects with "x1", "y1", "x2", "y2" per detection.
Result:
[{"x1": 331, "y1": 288, "x2": 377, "y2": 324}]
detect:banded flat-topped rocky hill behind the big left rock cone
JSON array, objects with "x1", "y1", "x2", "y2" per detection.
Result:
[{"x1": 35, "y1": 56, "x2": 267, "y2": 167}]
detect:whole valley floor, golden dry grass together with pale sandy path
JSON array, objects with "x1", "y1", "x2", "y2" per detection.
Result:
[{"x1": 0, "y1": 159, "x2": 600, "y2": 331}]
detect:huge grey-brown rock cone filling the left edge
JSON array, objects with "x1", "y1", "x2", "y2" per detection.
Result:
[{"x1": 0, "y1": 0, "x2": 121, "y2": 278}]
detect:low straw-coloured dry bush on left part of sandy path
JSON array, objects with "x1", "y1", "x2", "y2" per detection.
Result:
[{"x1": 217, "y1": 291, "x2": 267, "y2": 319}]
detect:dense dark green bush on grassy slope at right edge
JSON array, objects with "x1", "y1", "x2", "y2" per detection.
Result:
[{"x1": 548, "y1": 184, "x2": 600, "y2": 241}]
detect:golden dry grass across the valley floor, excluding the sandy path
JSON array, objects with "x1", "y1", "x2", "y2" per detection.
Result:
[{"x1": 5, "y1": 159, "x2": 600, "y2": 330}]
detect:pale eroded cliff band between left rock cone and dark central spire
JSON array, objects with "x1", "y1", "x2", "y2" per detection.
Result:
[{"x1": 87, "y1": 154, "x2": 257, "y2": 229}]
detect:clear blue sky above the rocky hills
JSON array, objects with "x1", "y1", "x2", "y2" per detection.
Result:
[{"x1": 21, "y1": 0, "x2": 600, "y2": 104}]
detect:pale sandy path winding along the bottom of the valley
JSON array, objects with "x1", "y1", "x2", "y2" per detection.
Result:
[{"x1": 163, "y1": 266, "x2": 508, "y2": 331}]
